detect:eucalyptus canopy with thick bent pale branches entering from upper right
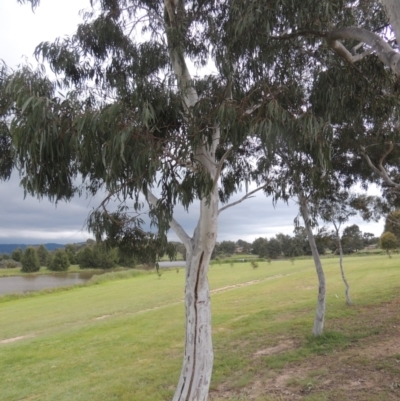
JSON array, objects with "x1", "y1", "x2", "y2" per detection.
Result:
[{"x1": 234, "y1": 0, "x2": 400, "y2": 200}]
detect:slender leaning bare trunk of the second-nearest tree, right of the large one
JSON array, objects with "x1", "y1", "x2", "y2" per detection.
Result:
[{"x1": 299, "y1": 194, "x2": 326, "y2": 336}]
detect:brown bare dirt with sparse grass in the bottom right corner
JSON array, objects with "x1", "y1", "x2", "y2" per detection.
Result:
[{"x1": 210, "y1": 298, "x2": 400, "y2": 401}]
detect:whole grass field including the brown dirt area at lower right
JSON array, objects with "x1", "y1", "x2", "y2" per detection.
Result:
[{"x1": 0, "y1": 255, "x2": 400, "y2": 401}]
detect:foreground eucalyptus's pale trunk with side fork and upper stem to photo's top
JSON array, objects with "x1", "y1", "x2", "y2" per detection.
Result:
[{"x1": 164, "y1": 0, "x2": 220, "y2": 401}]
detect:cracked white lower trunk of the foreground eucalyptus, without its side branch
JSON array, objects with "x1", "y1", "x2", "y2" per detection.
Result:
[{"x1": 173, "y1": 190, "x2": 218, "y2": 401}]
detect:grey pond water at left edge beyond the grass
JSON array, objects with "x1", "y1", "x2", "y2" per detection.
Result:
[{"x1": 0, "y1": 272, "x2": 103, "y2": 296}]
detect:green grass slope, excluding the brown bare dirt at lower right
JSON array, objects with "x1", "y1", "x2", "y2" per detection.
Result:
[{"x1": 0, "y1": 256, "x2": 399, "y2": 401}]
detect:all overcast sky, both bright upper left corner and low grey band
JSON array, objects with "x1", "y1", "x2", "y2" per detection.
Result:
[{"x1": 0, "y1": 0, "x2": 383, "y2": 244}]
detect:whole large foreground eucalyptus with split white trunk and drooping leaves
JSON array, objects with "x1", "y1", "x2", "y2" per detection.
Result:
[{"x1": 0, "y1": 0, "x2": 300, "y2": 401}]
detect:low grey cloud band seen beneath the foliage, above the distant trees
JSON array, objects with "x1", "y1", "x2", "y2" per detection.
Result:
[{"x1": 0, "y1": 175, "x2": 383, "y2": 243}]
